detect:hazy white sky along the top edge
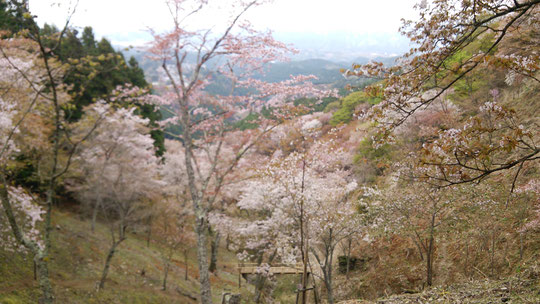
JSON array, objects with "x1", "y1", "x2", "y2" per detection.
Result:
[{"x1": 30, "y1": 0, "x2": 416, "y2": 57}]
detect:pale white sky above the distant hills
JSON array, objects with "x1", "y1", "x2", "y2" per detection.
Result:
[{"x1": 29, "y1": 0, "x2": 416, "y2": 59}]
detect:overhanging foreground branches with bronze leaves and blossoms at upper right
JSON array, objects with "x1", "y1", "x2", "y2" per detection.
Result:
[{"x1": 348, "y1": 0, "x2": 540, "y2": 186}]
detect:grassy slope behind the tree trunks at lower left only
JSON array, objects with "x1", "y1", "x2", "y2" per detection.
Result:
[{"x1": 0, "y1": 211, "x2": 248, "y2": 304}]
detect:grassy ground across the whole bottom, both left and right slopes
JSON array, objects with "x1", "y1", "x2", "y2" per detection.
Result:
[{"x1": 4, "y1": 208, "x2": 540, "y2": 304}]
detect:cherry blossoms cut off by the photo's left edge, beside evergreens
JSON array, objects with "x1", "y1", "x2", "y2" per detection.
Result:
[{"x1": 0, "y1": 55, "x2": 44, "y2": 251}]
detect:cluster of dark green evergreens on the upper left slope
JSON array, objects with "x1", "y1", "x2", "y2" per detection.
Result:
[{"x1": 0, "y1": 17, "x2": 164, "y2": 155}]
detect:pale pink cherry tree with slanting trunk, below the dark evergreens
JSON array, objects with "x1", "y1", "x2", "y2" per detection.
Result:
[{"x1": 67, "y1": 103, "x2": 163, "y2": 289}]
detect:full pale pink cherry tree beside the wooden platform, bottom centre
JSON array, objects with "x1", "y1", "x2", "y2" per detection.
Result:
[{"x1": 237, "y1": 135, "x2": 361, "y2": 303}]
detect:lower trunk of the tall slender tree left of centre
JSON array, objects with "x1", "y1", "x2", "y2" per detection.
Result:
[{"x1": 195, "y1": 217, "x2": 212, "y2": 304}]
